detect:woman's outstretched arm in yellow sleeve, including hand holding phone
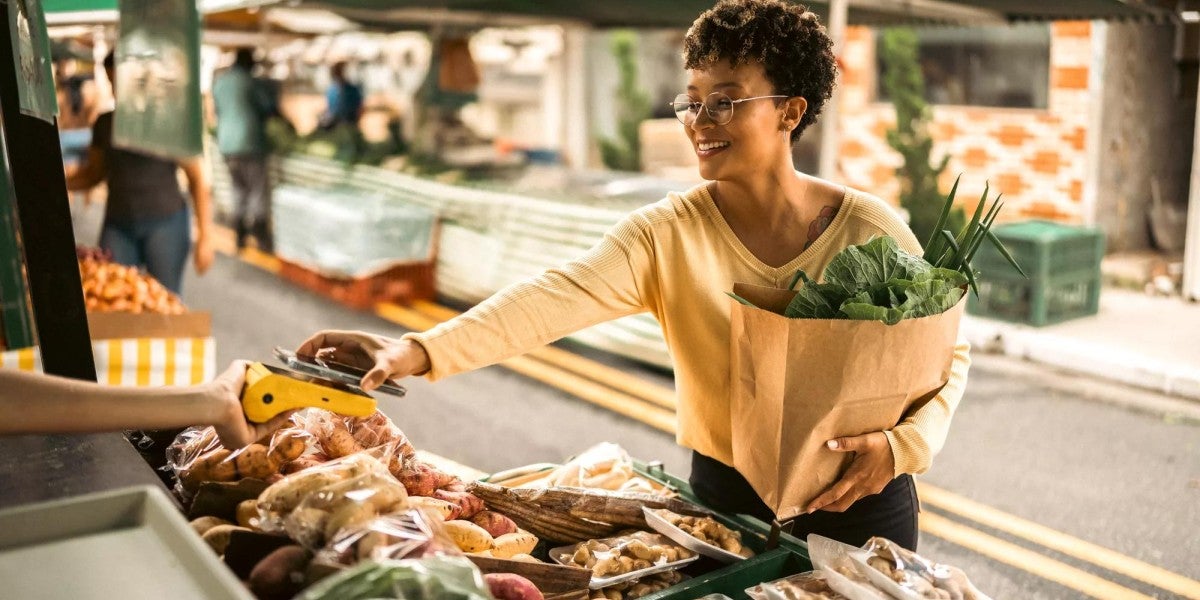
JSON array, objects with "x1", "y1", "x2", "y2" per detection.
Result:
[{"x1": 299, "y1": 214, "x2": 655, "y2": 389}]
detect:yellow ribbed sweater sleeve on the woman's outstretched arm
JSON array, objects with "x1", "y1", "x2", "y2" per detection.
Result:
[{"x1": 403, "y1": 214, "x2": 654, "y2": 380}]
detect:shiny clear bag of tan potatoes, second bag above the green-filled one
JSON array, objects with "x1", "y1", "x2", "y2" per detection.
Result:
[{"x1": 258, "y1": 445, "x2": 408, "y2": 550}]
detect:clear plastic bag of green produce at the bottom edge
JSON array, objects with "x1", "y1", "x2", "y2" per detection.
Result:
[{"x1": 296, "y1": 556, "x2": 492, "y2": 600}]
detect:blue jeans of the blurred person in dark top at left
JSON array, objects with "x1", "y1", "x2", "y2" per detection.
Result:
[{"x1": 100, "y1": 208, "x2": 192, "y2": 294}]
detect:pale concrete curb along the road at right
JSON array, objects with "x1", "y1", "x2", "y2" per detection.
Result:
[{"x1": 962, "y1": 316, "x2": 1200, "y2": 402}]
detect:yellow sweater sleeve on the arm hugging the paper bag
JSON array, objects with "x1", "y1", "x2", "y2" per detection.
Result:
[{"x1": 880, "y1": 199, "x2": 971, "y2": 476}]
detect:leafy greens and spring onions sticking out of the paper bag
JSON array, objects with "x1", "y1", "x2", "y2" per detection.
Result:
[{"x1": 730, "y1": 180, "x2": 1025, "y2": 325}]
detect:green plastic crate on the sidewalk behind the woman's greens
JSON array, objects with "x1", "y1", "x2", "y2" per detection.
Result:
[{"x1": 967, "y1": 221, "x2": 1104, "y2": 326}]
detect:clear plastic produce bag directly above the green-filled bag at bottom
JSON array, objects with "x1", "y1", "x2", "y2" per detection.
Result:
[{"x1": 318, "y1": 508, "x2": 462, "y2": 564}]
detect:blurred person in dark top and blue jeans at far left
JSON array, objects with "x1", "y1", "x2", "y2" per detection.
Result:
[{"x1": 67, "y1": 53, "x2": 212, "y2": 294}]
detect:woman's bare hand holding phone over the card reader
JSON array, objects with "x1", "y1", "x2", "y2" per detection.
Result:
[{"x1": 296, "y1": 330, "x2": 430, "y2": 391}]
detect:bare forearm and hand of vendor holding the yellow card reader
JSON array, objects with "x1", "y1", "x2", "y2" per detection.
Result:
[{"x1": 0, "y1": 361, "x2": 288, "y2": 449}]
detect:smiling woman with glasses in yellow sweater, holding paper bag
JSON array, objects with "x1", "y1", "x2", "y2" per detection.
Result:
[{"x1": 301, "y1": 0, "x2": 970, "y2": 548}]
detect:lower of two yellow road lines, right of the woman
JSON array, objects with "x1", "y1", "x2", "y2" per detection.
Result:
[{"x1": 920, "y1": 512, "x2": 1152, "y2": 600}]
